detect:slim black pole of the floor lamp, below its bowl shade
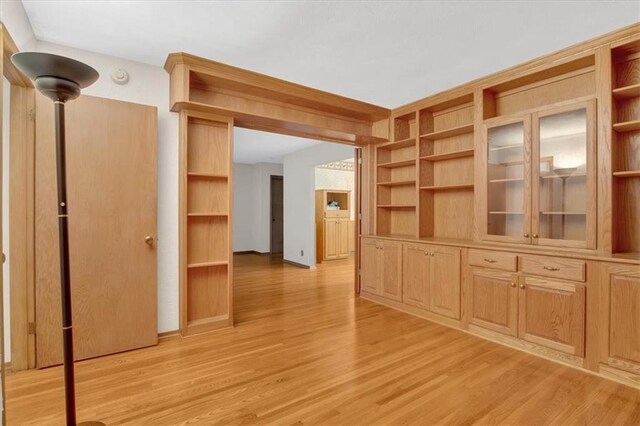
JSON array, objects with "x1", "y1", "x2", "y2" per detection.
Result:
[{"x1": 53, "y1": 101, "x2": 76, "y2": 425}]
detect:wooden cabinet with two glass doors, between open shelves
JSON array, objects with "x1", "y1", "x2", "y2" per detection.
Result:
[{"x1": 482, "y1": 101, "x2": 596, "y2": 248}]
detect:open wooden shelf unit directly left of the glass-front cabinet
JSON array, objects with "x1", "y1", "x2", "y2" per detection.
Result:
[{"x1": 418, "y1": 93, "x2": 475, "y2": 240}]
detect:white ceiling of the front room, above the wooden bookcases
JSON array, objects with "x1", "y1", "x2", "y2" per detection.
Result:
[{"x1": 23, "y1": 0, "x2": 640, "y2": 108}]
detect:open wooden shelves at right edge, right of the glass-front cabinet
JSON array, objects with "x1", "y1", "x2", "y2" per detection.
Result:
[{"x1": 611, "y1": 38, "x2": 640, "y2": 253}]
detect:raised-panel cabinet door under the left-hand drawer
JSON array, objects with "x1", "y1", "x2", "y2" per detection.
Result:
[{"x1": 471, "y1": 269, "x2": 518, "y2": 336}]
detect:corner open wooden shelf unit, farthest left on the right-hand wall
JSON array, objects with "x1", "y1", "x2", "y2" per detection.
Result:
[{"x1": 376, "y1": 112, "x2": 418, "y2": 236}]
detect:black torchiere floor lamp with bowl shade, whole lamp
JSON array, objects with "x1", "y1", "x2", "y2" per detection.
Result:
[{"x1": 11, "y1": 52, "x2": 101, "y2": 425}]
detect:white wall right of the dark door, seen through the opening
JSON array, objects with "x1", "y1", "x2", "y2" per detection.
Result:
[{"x1": 283, "y1": 143, "x2": 354, "y2": 267}]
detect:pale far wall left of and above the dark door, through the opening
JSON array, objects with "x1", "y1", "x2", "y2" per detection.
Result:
[{"x1": 233, "y1": 163, "x2": 282, "y2": 253}]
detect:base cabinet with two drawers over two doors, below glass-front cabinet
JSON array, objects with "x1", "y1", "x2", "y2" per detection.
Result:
[{"x1": 469, "y1": 250, "x2": 586, "y2": 357}]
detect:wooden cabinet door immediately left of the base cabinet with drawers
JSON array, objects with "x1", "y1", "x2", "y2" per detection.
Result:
[{"x1": 429, "y1": 246, "x2": 460, "y2": 319}]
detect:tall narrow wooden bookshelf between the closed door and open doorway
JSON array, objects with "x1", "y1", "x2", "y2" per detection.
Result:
[{"x1": 180, "y1": 111, "x2": 232, "y2": 335}]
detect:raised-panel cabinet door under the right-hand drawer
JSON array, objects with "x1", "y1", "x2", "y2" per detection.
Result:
[{"x1": 518, "y1": 277, "x2": 586, "y2": 356}]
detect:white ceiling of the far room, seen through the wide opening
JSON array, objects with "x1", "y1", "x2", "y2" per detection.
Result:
[{"x1": 233, "y1": 127, "x2": 324, "y2": 164}]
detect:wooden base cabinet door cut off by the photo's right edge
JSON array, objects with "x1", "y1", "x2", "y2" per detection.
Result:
[{"x1": 607, "y1": 266, "x2": 640, "y2": 366}]
